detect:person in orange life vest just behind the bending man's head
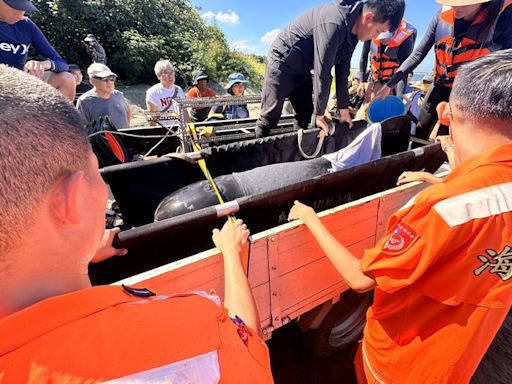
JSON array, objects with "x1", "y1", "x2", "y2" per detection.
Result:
[{"x1": 357, "y1": 20, "x2": 418, "y2": 104}]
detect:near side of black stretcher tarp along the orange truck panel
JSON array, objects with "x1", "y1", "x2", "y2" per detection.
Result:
[{"x1": 91, "y1": 140, "x2": 446, "y2": 283}]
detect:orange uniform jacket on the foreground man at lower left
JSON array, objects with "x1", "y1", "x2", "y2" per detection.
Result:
[{"x1": 0, "y1": 286, "x2": 272, "y2": 384}]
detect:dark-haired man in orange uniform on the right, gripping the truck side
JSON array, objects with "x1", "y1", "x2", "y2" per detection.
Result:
[{"x1": 289, "y1": 49, "x2": 512, "y2": 384}]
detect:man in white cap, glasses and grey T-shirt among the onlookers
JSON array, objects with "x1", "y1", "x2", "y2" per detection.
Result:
[{"x1": 76, "y1": 63, "x2": 132, "y2": 129}]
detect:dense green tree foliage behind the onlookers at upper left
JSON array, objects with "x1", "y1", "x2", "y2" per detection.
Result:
[{"x1": 31, "y1": 0, "x2": 264, "y2": 88}]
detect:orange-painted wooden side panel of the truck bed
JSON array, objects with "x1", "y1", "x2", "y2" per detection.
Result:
[{"x1": 116, "y1": 183, "x2": 426, "y2": 336}]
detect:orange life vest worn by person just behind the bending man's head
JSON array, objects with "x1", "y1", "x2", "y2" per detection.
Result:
[{"x1": 370, "y1": 20, "x2": 416, "y2": 81}]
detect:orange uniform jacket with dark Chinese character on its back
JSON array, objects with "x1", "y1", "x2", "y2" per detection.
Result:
[{"x1": 361, "y1": 144, "x2": 512, "y2": 384}]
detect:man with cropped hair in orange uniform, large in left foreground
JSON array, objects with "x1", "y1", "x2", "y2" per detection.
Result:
[{"x1": 0, "y1": 66, "x2": 272, "y2": 384}]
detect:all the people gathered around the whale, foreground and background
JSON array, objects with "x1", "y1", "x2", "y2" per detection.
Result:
[{"x1": 0, "y1": 0, "x2": 512, "y2": 384}]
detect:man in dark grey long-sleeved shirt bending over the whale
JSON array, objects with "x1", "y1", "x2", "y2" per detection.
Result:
[{"x1": 256, "y1": 0, "x2": 405, "y2": 137}]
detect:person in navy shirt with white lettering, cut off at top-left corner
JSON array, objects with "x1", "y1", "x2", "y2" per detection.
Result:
[{"x1": 0, "y1": 0, "x2": 75, "y2": 101}]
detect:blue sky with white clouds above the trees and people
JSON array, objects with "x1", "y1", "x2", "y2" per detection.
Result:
[{"x1": 191, "y1": 0, "x2": 440, "y2": 72}]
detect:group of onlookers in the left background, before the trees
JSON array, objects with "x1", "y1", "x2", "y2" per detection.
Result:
[{"x1": 0, "y1": 0, "x2": 255, "y2": 128}]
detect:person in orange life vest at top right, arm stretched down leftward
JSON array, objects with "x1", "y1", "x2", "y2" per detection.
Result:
[{"x1": 377, "y1": 0, "x2": 512, "y2": 139}]
